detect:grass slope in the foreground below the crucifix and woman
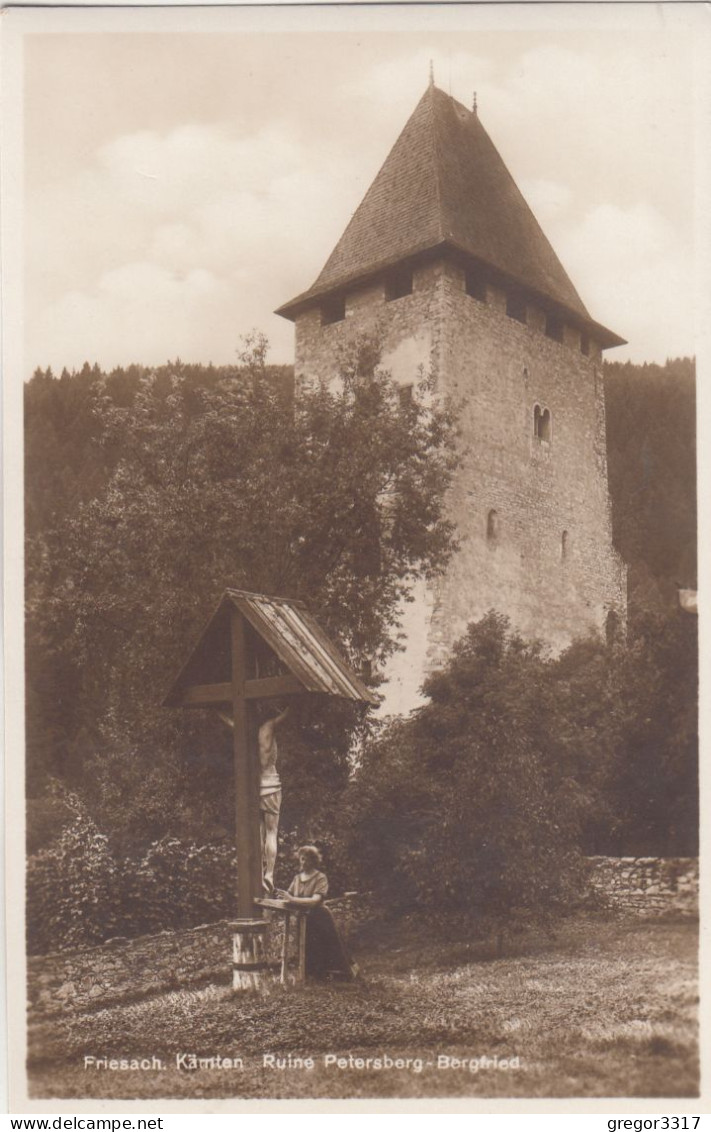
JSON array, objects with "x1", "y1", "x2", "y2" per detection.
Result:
[{"x1": 28, "y1": 916, "x2": 699, "y2": 1099}]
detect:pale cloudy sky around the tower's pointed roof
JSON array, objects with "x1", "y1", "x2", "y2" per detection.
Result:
[{"x1": 23, "y1": 5, "x2": 700, "y2": 377}]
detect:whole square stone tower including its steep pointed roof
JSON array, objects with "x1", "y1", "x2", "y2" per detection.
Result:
[{"x1": 277, "y1": 82, "x2": 626, "y2": 711}]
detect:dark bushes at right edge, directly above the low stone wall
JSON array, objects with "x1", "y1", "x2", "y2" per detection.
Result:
[{"x1": 538, "y1": 609, "x2": 699, "y2": 856}]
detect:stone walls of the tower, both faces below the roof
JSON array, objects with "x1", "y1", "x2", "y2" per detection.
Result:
[{"x1": 297, "y1": 259, "x2": 626, "y2": 711}]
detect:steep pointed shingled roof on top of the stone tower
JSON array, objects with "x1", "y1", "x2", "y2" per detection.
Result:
[{"x1": 277, "y1": 85, "x2": 623, "y2": 345}]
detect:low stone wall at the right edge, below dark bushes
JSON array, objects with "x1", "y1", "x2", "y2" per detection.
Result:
[{"x1": 588, "y1": 857, "x2": 699, "y2": 917}]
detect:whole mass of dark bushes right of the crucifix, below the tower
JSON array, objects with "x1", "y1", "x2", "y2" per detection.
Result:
[{"x1": 344, "y1": 612, "x2": 697, "y2": 924}]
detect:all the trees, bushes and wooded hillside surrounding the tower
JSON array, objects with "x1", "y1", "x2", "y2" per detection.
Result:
[{"x1": 25, "y1": 348, "x2": 696, "y2": 950}]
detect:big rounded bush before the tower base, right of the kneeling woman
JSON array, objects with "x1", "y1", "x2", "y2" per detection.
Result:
[{"x1": 348, "y1": 612, "x2": 588, "y2": 923}]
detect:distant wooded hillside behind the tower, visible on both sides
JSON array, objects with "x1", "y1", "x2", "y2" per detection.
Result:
[{"x1": 25, "y1": 358, "x2": 696, "y2": 609}]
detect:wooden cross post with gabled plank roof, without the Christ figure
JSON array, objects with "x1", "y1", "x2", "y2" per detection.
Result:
[{"x1": 163, "y1": 590, "x2": 378, "y2": 920}]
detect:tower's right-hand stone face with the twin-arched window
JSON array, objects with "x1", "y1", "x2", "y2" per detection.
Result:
[{"x1": 430, "y1": 265, "x2": 625, "y2": 663}]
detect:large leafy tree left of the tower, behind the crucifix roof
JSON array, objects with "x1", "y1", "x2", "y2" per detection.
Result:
[{"x1": 28, "y1": 337, "x2": 455, "y2": 843}]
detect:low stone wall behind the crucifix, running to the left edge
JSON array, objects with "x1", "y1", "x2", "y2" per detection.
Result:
[{"x1": 27, "y1": 894, "x2": 365, "y2": 1021}]
